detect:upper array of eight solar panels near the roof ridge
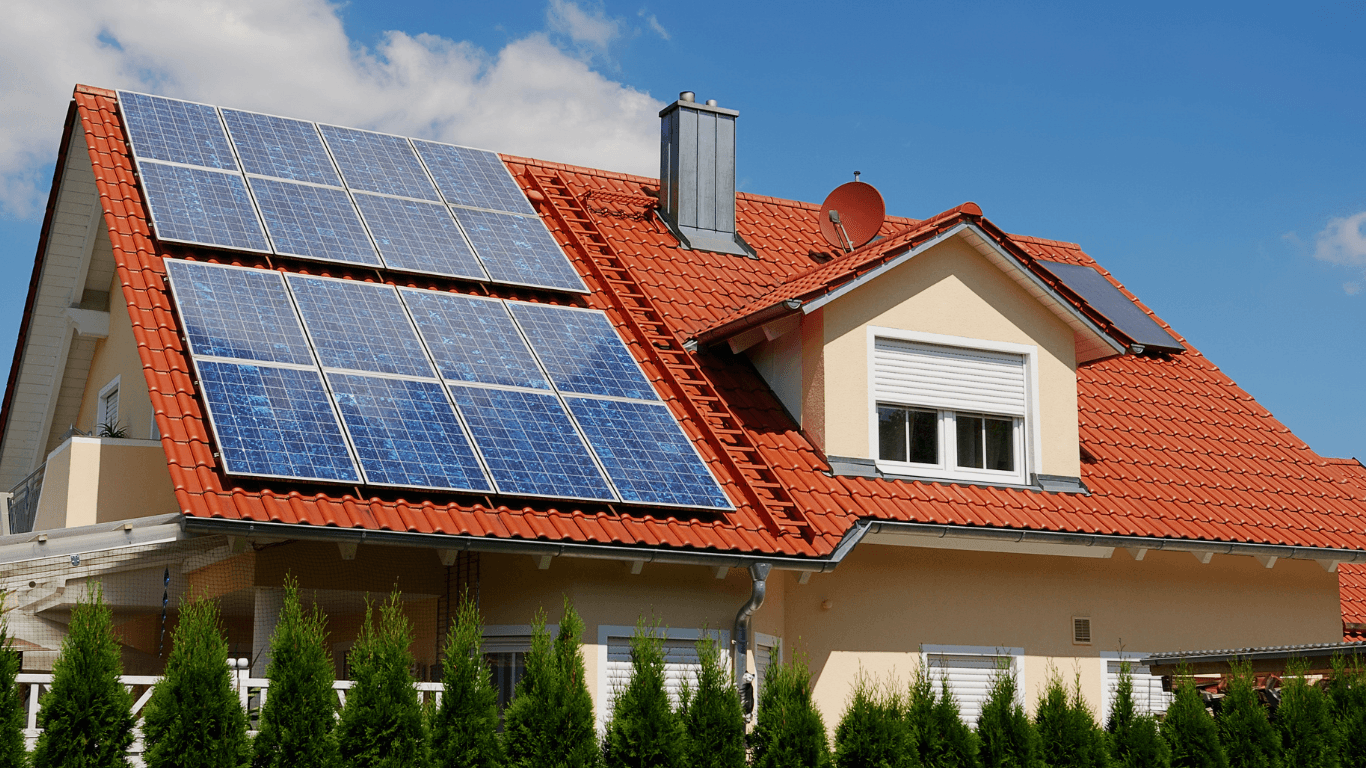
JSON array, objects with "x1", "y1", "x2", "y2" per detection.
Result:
[{"x1": 119, "y1": 92, "x2": 587, "y2": 292}]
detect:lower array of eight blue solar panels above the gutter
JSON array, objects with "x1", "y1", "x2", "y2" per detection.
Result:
[{"x1": 167, "y1": 258, "x2": 732, "y2": 510}]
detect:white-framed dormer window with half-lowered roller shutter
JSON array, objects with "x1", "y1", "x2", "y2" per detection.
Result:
[{"x1": 869, "y1": 328, "x2": 1038, "y2": 484}]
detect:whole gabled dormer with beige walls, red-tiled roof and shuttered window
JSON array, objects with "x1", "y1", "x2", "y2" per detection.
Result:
[{"x1": 697, "y1": 204, "x2": 1163, "y2": 492}]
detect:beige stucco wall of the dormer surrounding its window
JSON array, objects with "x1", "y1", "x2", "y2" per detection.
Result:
[{"x1": 802, "y1": 238, "x2": 1081, "y2": 477}]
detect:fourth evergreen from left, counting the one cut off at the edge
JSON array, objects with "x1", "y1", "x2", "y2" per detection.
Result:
[{"x1": 253, "y1": 575, "x2": 339, "y2": 768}]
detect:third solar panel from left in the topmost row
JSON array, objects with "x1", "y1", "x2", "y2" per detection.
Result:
[{"x1": 318, "y1": 126, "x2": 441, "y2": 201}]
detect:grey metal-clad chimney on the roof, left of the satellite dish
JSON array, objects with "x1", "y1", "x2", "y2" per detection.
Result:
[{"x1": 660, "y1": 90, "x2": 755, "y2": 257}]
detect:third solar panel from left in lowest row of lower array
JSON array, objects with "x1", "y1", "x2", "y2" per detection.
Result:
[{"x1": 451, "y1": 387, "x2": 613, "y2": 500}]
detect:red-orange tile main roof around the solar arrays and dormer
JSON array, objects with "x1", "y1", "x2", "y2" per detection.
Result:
[{"x1": 66, "y1": 87, "x2": 1366, "y2": 556}]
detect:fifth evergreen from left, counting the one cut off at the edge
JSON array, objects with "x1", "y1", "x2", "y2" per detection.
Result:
[{"x1": 337, "y1": 589, "x2": 428, "y2": 768}]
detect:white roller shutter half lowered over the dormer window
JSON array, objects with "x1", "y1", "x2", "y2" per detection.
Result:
[{"x1": 873, "y1": 339, "x2": 1029, "y2": 417}]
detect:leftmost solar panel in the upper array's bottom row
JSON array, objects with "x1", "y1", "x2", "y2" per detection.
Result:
[{"x1": 138, "y1": 163, "x2": 270, "y2": 253}]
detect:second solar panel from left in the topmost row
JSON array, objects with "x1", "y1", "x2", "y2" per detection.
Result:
[{"x1": 223, "y1": 109, "x2": 342, "y2": 187}]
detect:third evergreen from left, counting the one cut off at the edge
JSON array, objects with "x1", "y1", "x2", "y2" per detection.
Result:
[{"x1": 142, "y1": 597, "x2": 251, "y2": 768}]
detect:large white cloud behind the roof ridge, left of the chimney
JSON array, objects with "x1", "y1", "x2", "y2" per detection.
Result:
[{"x1": 0, "y1": 0, "x2": 663, "y2": 217}]
